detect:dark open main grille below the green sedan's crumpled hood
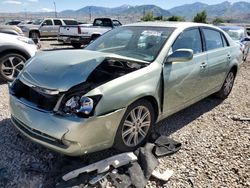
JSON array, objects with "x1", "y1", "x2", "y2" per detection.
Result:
[{"x1": 10, "y1": 80, "x2": 59, "y2": 111}]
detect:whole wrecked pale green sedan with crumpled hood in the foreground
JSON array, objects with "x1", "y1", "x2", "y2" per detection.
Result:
[{"x1": 9, "y1": 22, "x2": 242, "y2": 155}]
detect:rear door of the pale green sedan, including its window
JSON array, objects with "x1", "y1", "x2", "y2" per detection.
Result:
[{"x1": 201, "y1": 28, "x2": 231, "y2": 93}]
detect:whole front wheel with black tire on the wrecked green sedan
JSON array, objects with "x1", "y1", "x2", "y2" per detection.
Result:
[{"x1": 114, "y1": 99, "x2": 155, "y2": 152}]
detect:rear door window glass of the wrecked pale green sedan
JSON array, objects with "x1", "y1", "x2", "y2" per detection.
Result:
[{"x1": 203, "y1": 29, "x2": 223, "y2": 50}]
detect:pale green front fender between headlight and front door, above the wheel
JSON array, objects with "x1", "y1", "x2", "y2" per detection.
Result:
[{"x1": 86, "y1": 62, "x2": 162, "y2": 115}]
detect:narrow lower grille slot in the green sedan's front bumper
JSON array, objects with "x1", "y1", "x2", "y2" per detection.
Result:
[{"x1": 11, "y1": 116, "x2": 67, "y2": 149}]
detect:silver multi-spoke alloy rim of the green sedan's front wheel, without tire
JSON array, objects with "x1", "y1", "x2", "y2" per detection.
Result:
[{"x1": 122, "y1": 106, "x2": 151, "y2": 147}]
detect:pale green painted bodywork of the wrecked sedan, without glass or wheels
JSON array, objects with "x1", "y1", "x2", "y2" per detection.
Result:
[{"x1": 10, "y1": 22, "x2": 241, "y2": 156}]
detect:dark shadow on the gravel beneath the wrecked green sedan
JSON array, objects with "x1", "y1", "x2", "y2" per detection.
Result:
[{"x1": 0, "y1": 97, "x2": 222, "y2": 187}]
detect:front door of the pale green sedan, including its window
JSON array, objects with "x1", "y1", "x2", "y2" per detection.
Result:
[{"x1": 163, "y1": 28, "x2": 207, "y2": 115}]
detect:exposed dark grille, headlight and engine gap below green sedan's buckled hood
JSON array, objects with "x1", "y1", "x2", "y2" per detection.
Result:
[{"x1": 10, "y1": 53, "x2": 147, "y2": 118}]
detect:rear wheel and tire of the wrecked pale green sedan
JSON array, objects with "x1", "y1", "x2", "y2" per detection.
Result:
[{"x1": 215, "y1": 70, "x2": 236, "y2": 99}]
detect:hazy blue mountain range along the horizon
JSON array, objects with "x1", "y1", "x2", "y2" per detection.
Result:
[{"x1": 59, "y1": 1, "x2": 250, "y2": 22}]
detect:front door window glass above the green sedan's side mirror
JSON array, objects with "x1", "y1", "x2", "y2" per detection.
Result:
[{"x1": 172, "y1": 28, "x2": 202, "y2": 54}]
